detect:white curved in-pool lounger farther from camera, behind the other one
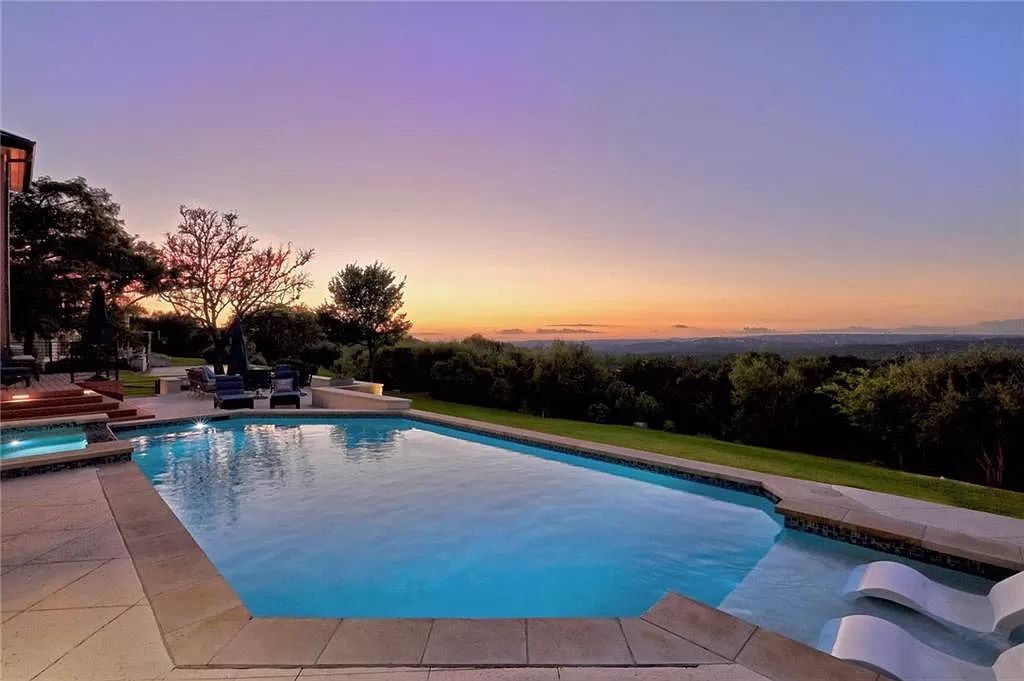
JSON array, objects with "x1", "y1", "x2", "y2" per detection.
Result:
[{"x1": 843, "y1": 560, "x2": 1024, "y2": 636}]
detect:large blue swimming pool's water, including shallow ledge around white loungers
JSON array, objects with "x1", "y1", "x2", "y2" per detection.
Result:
[{"x1": 119, "y1": 417, "x2": 1001, "y2": 663}]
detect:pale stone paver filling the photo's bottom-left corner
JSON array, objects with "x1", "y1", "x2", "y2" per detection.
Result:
[{"x1": 0, "y1": 607, "x2": 125, "y2": 681}]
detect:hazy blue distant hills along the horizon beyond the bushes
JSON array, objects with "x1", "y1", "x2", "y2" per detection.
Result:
[{"x1": 516, "y1": 333, "x2": 1024, "y2": 358}]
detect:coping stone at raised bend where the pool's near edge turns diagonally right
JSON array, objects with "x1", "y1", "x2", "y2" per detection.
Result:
[{"x1": 642, "y1": 593, "x2": 756, "y2": 659}]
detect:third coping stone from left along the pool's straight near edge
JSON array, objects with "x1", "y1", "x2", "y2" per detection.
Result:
[{"x1": 423, "y1": 620, "x2": 526, "y2": 665}]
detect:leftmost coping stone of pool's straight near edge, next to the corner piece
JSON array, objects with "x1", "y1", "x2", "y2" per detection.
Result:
[{"x1": 211, "y1": 618, "x2": 339, "y2": 667}]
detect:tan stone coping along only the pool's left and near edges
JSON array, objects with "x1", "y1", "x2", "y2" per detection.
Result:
[{"x1": 96, "y1": 462, "x2": 878, "y2": 681}]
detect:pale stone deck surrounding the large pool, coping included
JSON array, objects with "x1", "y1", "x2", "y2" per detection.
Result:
[{"x1": 0, "y1": 395, "x2": 1024, "y2": 681}]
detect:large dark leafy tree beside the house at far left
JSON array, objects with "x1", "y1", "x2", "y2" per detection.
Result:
[{"x1": 10, "y1": 177, "x2": 168, "y2": 348}]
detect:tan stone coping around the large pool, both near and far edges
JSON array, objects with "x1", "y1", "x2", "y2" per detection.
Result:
[{"x1": 97, "y1": 410, "x2": 1024, "y2": 681}]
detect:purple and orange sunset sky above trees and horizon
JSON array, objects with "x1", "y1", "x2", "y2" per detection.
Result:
[{"x1": 0, "y1": 2, "x2": 1024, "y2": 339}]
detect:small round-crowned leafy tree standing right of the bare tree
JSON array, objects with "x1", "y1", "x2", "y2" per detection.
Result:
[{"x1": 318, "y1": 262, "x2": 413, "y2": 381}]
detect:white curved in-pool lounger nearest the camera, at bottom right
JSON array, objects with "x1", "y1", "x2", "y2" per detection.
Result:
[{"x1": 818, "y1": 614, "x2": 1024, "y2": 681}]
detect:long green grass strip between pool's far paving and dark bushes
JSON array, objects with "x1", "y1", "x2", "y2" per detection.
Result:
[{"x1": 406, "y1": 394, "x2": 1024, "y2": 518}]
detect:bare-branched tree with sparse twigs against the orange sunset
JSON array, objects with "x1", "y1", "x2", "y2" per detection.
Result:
[{"x1": 160, "y1": 206, "x2": 313, "y2": 373}]
